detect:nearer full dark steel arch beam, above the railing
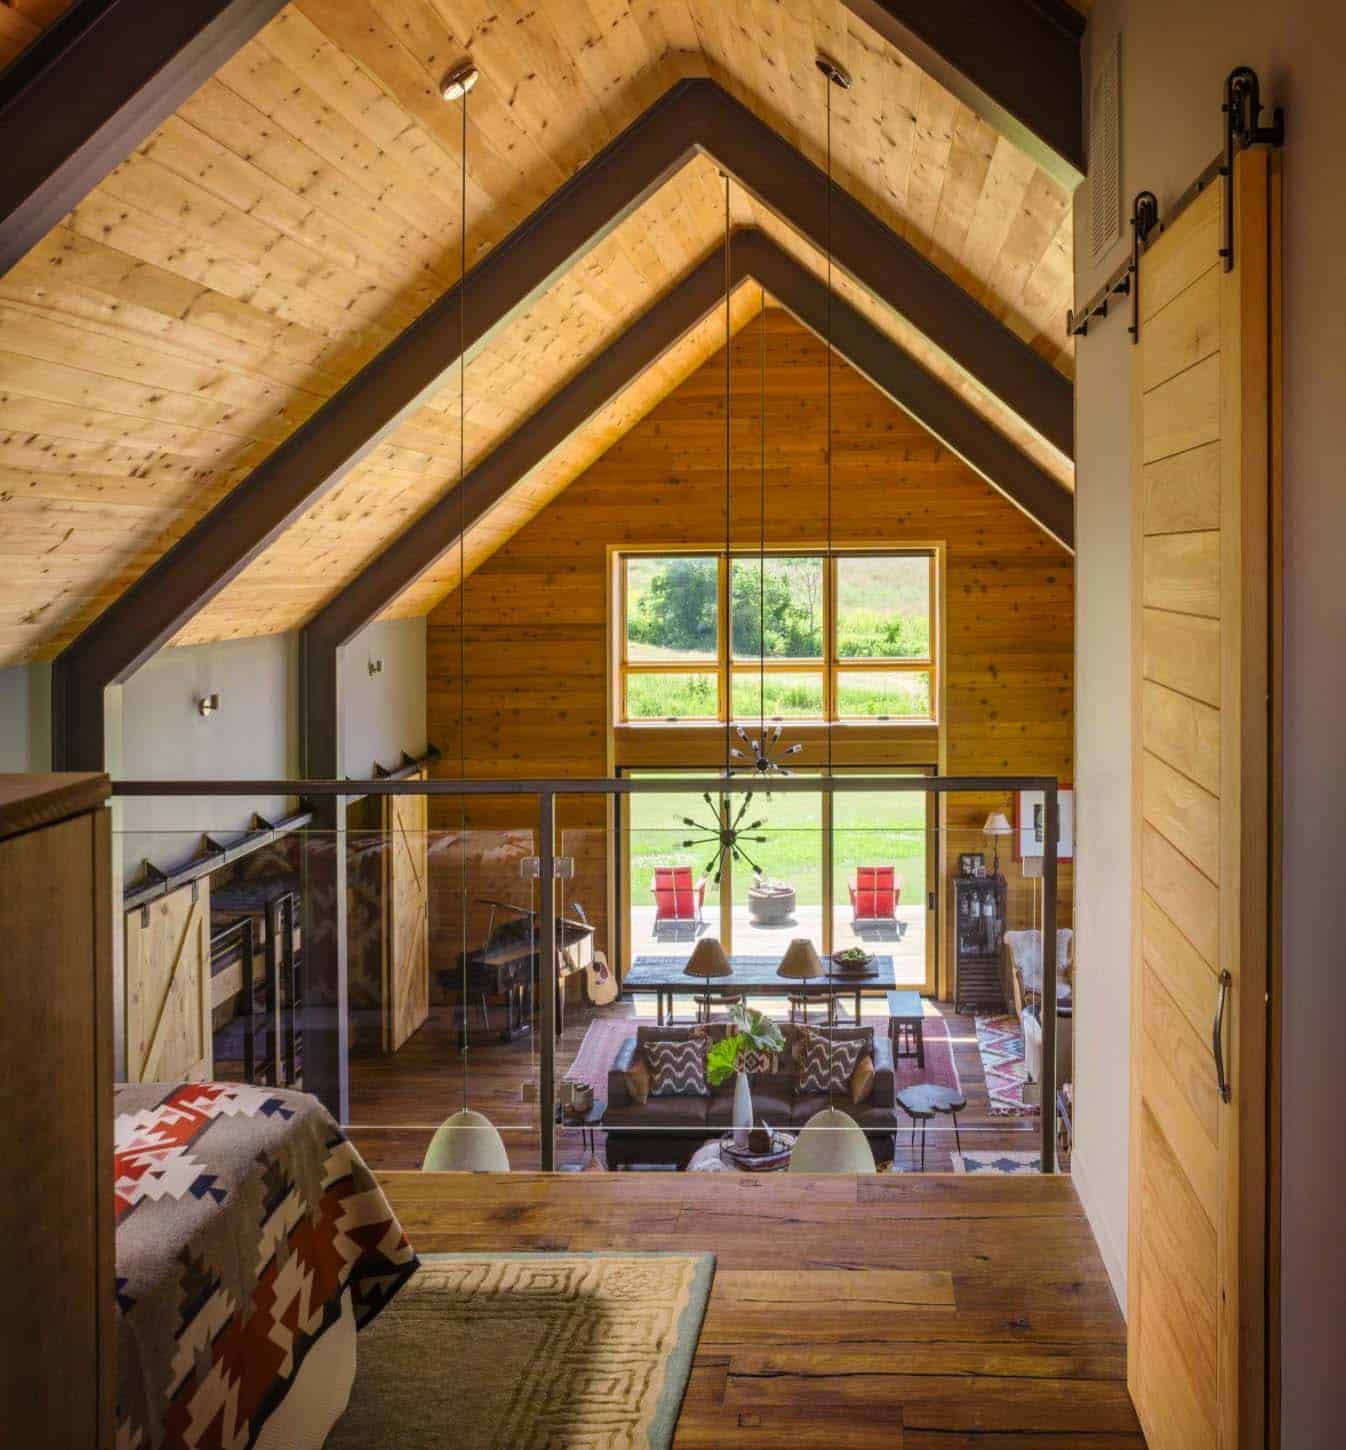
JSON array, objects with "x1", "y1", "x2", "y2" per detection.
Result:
[{"x1": 52, "y1": 77, "x2": 1073, "y2": 770}]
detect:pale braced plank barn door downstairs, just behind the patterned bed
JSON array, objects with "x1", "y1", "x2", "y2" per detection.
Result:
[{"x1": 126, "y1": 880, "x2": 215, "y2": 1083}]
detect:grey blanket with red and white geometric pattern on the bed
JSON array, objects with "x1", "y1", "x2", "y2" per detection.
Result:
[{"x1": 115, "y1": 1083, "x2": 416, "y2": 1450}]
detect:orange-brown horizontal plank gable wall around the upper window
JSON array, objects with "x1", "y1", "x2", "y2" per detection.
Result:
[{"x1": 428, "y1": 307, "x2": 1073, "y2": 986}]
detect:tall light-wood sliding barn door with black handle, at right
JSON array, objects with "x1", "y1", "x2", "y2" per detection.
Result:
[{"x1": 1127, "y1": 151, "x2": 1279, "y2": 1450}]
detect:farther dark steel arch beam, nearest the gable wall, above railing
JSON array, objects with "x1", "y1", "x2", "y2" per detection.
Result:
[{"x1": 299, "y1": 228, "x2": 1075, "y2": 780}]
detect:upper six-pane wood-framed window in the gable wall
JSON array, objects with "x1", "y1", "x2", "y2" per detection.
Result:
[{"x1": 618, "y1": 551, "x2": 937, "y2": 724}]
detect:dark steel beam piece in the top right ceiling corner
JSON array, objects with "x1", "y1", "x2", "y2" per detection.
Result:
[{"x1": 843, "y1": 0, "x2": 1086, "y2": 190}]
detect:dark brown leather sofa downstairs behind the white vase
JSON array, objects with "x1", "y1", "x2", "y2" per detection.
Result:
[{"x1": 602, "y1": 1022, "x2": 896, "y2": 1169}]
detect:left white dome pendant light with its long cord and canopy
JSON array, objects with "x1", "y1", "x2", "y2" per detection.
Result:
[{"x1": 421, "y1": 62, "x2": 509, "y2": 1173}]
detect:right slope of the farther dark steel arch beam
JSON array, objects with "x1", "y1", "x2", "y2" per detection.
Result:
[{"x1": 734, "y1": 231, "x2": 1075, "y2": 551}]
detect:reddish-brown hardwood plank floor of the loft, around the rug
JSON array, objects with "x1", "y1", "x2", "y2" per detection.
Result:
[{"x1": 379, "y1": 1173, "x2": 1144, "y2": 1450}]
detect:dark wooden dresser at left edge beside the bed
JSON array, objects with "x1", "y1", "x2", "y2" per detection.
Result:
[{"x1": 0, "y1": 774, "x2": 116, "y2": 1450}]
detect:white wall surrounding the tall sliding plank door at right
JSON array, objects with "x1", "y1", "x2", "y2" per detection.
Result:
[{"x1": 1076, "y1": 0, "x2": 1346, "y2": 1450}]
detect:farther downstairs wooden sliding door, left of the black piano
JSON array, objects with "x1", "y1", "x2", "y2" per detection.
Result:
[{"x1": 383, "y1": 771, "x2": 429, "y2": 1053}]
